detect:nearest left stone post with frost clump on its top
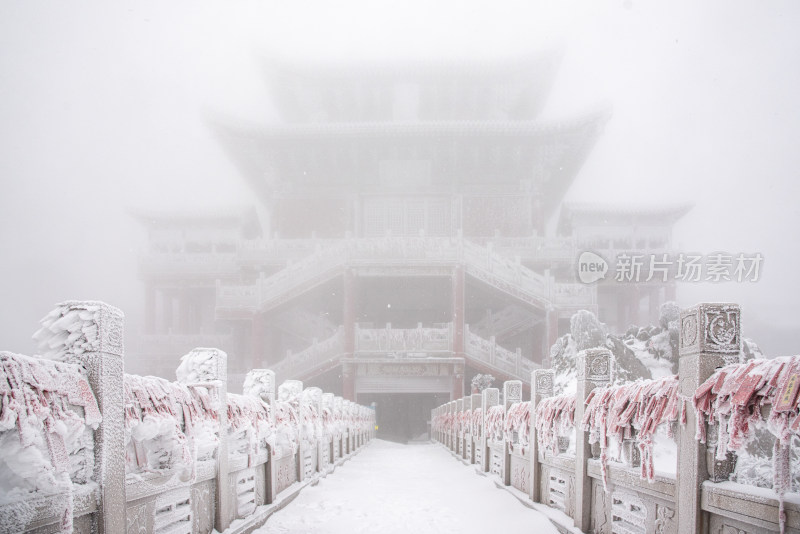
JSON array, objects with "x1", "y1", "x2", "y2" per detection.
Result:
[{"x1": 49, "y1": 301, "x2": 125, "y2": 534}]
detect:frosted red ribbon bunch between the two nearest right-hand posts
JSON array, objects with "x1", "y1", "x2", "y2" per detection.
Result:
[{"x1": 581, "y1": 376, "x2": 683, "y2": 486}]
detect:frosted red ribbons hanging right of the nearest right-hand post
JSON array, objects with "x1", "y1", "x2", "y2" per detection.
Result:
[{"x1": 693, "y1": 356, "x2": 800, "y2": 530}]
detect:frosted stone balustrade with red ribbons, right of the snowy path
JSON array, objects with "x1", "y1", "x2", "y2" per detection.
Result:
[{"x1": 431, "y1": 304, "x2": 800, "y2": 534}]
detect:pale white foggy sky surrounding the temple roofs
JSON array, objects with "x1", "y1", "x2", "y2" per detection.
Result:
[{"x1": 0, "y1": 0, "x2": 800, "y2": 355}]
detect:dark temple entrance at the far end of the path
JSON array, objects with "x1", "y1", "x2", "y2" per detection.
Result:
[{"x1": 357, "y1": 393, "x2": 450, "y2": 443}]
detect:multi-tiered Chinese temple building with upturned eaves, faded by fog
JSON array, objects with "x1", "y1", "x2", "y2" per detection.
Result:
[{"x1": 135, "y1": 52, "x2": 686, "y2": 442}]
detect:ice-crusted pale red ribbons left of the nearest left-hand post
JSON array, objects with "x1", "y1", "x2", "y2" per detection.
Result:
[{"x1": 0, "y1": 354, "x2": 102, "y2": 532}]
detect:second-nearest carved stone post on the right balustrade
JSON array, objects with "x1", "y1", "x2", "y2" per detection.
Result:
[{"x1": 573, "y1": 349, "x2": 611, "y2": 532}]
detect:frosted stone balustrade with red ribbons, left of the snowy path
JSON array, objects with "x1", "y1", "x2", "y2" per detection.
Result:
[{"x1": 0, "y1": 302, "x2": 375, "y2": 534}]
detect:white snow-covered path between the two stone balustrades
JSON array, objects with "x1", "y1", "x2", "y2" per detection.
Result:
[{"x1": 256, "y1": 440, "x2": 558, "y2": 534}]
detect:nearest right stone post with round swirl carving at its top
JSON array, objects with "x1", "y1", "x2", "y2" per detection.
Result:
[{"x1": 675, "y1": 304, "x2": 741, "y2": 533}]
